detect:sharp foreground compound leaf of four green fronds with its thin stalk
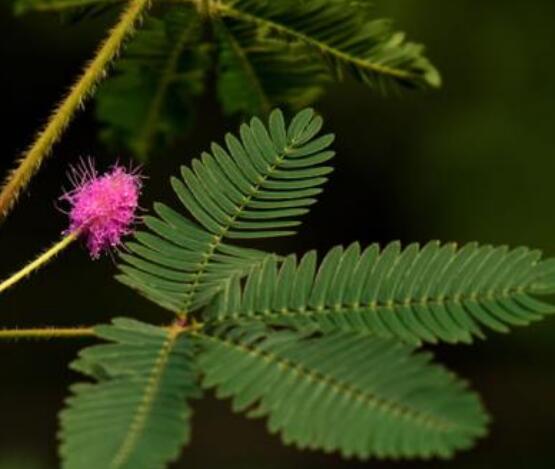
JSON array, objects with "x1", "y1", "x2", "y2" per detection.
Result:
[{"x1": 0, "y1": 109, "x2": 555, "y2": 469}]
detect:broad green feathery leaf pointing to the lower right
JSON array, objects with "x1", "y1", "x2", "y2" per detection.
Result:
[{"x1": 197, "y1": 327, "x2": 487, "y2": 459}]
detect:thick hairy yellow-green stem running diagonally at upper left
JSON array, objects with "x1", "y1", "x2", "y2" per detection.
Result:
[{"x1": 0, "y1": 0, "x2": 150, "y2": 220}]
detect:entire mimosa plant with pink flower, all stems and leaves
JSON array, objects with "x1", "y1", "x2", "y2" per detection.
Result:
[{"x1": 0, "y1": 0, "x2": 555, "y2": 469}]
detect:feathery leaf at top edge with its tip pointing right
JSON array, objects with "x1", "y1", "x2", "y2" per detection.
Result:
[{"x1": 215, "y1": 0, "x2": 441, "y2": 91}]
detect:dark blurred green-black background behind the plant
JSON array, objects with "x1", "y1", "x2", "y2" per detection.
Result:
[{"x1": 0, "y1": 0, "x2": 555, "y2": 469}]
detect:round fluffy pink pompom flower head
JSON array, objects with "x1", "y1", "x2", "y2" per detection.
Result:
[{"x1": 61, "y1": 159, "x2": 142, "y2": 259}]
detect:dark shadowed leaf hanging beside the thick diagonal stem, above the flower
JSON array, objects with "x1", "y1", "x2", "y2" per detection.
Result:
[{"x1": 97, "y1": 6, "x2": 209, "y2": 161}]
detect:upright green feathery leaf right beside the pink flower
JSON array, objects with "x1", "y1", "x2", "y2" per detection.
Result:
[{"x1": 118, "y1": 109, "x2": 334, "y2": 313}]
